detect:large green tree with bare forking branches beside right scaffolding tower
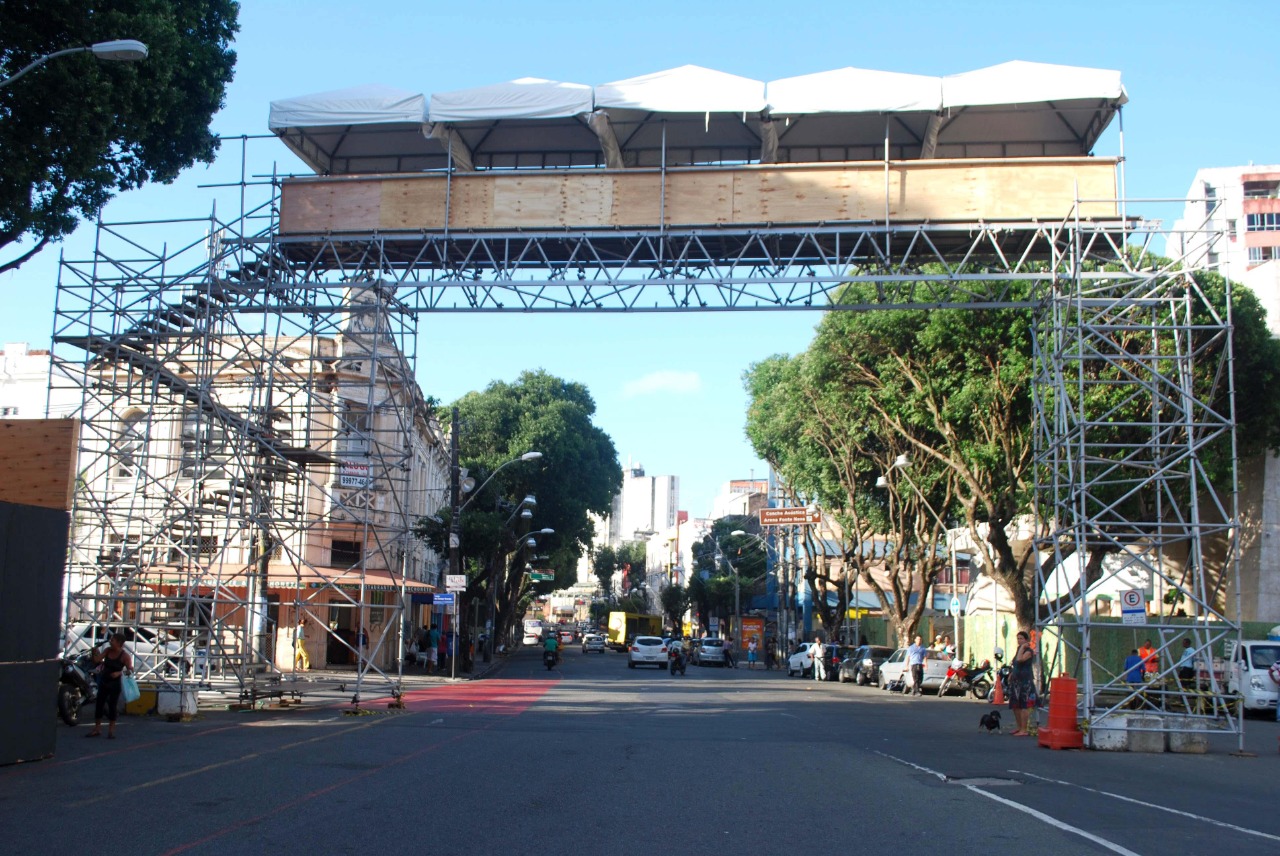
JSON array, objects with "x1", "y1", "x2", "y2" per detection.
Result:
[{"x1": 746, "y1": 267, "x2": 1280, "y2": 638}]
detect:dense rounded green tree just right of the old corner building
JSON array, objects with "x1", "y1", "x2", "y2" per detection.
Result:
[{"x1": 417, "y1": 371, "x2": 622, "y2": 660}]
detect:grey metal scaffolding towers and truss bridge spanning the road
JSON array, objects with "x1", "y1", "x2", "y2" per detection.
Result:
[{"x1": 54, "y1": 150, "x2": 1239, "y2": 731}]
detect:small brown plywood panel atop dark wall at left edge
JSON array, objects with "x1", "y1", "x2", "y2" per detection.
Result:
[{"x1": 0, "y1": 420, "x2": 79, "y2": 509}]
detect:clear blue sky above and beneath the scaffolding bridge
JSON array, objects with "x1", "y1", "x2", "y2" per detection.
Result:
[{"x1": 0, "y1": 0, "x2": 1280, "y2": 516}]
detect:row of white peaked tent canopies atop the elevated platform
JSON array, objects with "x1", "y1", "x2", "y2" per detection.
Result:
[{"x1": 269, "y1": 61, "x2": 1128, "y2": 174}]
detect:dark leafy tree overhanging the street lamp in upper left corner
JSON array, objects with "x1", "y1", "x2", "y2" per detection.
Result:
[{"x1": 0, "y1": 0, "x2": 239, "y2": 271}]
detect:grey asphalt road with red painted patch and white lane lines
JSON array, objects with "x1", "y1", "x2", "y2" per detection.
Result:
[{"x1": 10, "y1": 650, "x2": 1280, "y2": 856}]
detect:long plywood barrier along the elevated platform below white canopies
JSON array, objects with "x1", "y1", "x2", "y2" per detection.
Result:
[{"x1": 280, "y1": 157, "x2": 1116, "y2": 234}]
